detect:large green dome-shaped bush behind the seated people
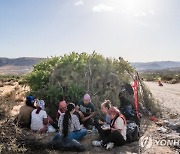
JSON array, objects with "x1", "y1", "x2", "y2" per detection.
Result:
[{"x1": 25, "y1": 52, "x2": 159, "y2": 117}]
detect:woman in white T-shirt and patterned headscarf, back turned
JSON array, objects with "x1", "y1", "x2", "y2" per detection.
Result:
[{"x1": 31, "y1": 100, "x2": 48, "y2": 133}]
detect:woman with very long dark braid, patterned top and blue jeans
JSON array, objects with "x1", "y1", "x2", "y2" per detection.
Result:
[{"x1": 58, "y1": 103, "x2": 87, "y2": 140}]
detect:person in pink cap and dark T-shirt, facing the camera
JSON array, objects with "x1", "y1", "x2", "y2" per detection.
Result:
[{"x1": 76, "y1": 94, "x2": 95, "y2": 129}]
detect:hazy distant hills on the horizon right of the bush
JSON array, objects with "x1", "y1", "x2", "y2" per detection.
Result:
[{"x1": 131, "y1": 61, "x2": 180, "y2": 71}]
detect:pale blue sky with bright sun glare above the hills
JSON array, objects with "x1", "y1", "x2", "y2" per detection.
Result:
[{"x1": 0, "y1": 0, "x2": 180, "y2": 62}]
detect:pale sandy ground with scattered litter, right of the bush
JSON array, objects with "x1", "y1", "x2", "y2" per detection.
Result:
[{"x1": 143, "y1": 82, "x2": 180, "y2": 154}]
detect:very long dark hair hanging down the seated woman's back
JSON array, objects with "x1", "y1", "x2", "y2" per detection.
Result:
[{"x1": 63, "y1": 103, "x2": 75, "y2": 138}]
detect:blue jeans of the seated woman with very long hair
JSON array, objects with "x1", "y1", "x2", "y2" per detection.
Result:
[{"x1": 68, "y1": 128, "x2": 87, "y2": 140}]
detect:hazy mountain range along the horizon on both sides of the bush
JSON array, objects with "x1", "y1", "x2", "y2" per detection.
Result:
[{"x1": 0, "y1": 57, "x2": 180, "y2": 75}]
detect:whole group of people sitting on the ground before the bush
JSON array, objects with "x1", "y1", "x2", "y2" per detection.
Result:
[{"x1": 18, "y1": 94, "x2": 127, "y2": 149}]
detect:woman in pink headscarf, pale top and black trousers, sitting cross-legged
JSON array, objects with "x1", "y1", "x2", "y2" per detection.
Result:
[{"x1": 92, "y1": 106, "x2": 127, "y2": 149}]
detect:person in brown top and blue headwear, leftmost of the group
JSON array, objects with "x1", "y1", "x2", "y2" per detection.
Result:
[{"x1": 17, "y1": 95, "x2": 36, "y2": 128}]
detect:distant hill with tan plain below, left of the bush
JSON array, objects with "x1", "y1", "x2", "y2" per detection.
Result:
[{"x1": 0, "y1": 57, "x2": 45, "y2": 75}]
